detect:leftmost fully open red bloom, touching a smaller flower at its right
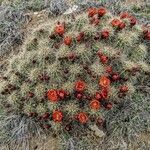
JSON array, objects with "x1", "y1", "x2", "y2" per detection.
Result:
[{"x1": 47, "y1": 90, "x2": 59, "y2": 102}]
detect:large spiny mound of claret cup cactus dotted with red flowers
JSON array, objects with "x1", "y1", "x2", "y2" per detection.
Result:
[{"x1": 0, "y1": 8, "x2": 150, "y2": 137}]
